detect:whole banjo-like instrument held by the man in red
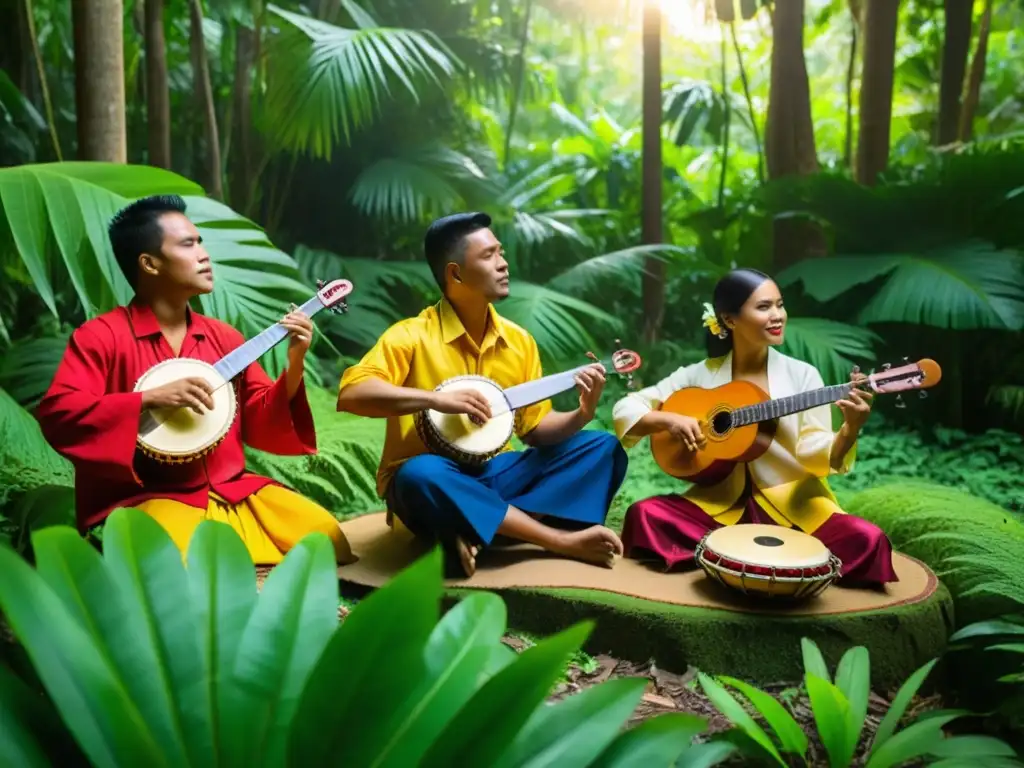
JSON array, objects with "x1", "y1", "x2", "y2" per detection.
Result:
[{"x1": 133, "y1": 280, "x2": 352, "y2": 464}]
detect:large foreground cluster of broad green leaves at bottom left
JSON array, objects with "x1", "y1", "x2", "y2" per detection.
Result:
[{"x1": 0, "y1": 509, "x2": 745, "y2": 767}]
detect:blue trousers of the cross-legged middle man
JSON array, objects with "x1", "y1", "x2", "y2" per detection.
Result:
[{"x1": 386, "y1": 430, "x2": 628, "y2": 545}]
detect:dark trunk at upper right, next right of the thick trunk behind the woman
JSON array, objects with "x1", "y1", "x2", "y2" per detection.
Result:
[{"x1": 856, "y1": 0, "x2": 899, "y2": 186}]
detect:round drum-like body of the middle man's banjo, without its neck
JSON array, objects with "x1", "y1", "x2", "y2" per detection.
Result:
[{"x1": 416, "y1": 376, "x2": 515, "y2": 466}]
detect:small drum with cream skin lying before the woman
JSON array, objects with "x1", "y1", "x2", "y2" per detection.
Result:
[{"x1": 696, "y1": 523, "x2": 842, "y2": 600}]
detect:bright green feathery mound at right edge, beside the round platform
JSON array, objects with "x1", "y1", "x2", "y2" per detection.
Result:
[{"x1": 847, "y1": 481, "x2": 1024, "y2": 626}]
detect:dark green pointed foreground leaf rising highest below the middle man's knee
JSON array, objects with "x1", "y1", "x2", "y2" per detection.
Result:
[{"x1": 290, "y1": 549, "x2": 446, "y2": 765}]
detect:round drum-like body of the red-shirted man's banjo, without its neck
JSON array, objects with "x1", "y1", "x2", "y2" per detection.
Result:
[{"x1": 134, "y1": 357, "x2": 238, "y2": 464}]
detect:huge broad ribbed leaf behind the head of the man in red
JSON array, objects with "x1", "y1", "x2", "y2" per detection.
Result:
[{"x1": 0, "y1": 163, "x2": 312, "y2": 370}]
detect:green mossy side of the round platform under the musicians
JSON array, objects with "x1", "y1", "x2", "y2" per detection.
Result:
[{"x1": 342, "y1": 584, "x2": 953, "y2": 690}]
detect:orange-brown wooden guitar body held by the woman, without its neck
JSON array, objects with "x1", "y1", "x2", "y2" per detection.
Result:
[{"x1": 650, "y1": 381, "x2": 777, "y2": 484}]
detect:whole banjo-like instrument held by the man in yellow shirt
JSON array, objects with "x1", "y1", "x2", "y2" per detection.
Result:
[{"x1": 416, "y1": 349, "x2": 641, "y2": 466}]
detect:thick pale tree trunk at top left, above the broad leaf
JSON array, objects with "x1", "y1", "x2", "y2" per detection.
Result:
[{"x1": 71, "y1": 0, "x2": 128, "y2": 163}]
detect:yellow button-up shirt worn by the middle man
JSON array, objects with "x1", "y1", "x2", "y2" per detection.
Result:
[{"x1": 339, "y1": 299, "x2": 551, "y2": 499}]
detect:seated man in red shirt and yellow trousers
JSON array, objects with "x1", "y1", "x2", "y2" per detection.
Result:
[{"x1": 37, "y1": 196, "x2": 354, "y2": 564}]
